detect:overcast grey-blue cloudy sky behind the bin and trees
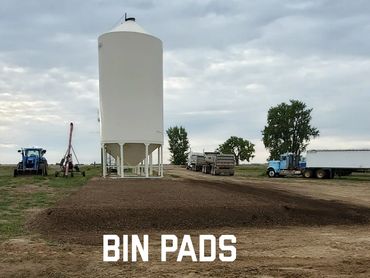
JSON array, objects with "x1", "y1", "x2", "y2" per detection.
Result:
[{"x1": 0, "y1": 0, "x2": 370, "y2": 163}]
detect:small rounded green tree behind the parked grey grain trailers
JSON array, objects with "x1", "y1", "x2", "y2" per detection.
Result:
[{"x1": 217, "y1": 136, "x2": 254, "y2": 165}]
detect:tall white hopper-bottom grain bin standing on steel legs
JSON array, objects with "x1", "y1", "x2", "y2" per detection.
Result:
[{"x1": 98, "y1": 18, "x2": 163, "y2": 177}]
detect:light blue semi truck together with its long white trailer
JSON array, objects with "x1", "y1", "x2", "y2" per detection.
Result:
[{"x1": 267, "y1": 149, "x2": 370, "y2": 179}]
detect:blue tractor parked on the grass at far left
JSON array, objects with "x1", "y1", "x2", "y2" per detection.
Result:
[{"x1": 14, "y1": 148, "x2": 48, "y2": 177}]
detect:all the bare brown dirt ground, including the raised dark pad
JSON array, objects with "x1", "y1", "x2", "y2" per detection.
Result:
[{"x1": 0, "y1": 169, "x2": 370, "y2": 277}]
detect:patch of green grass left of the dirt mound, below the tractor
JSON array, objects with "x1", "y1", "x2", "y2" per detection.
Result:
[{"x1": 0, "y1": 166, "x2": 100, "y2": 241}]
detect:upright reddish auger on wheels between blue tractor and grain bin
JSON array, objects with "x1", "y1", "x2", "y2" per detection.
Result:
[{"x1": 55, "y1": 123, "x2": 85, "y2": 177}]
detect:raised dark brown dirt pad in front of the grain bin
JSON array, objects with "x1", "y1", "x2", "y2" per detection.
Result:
[{"x1": 29, "y1": 179, "x2": 370, "y2": 244}]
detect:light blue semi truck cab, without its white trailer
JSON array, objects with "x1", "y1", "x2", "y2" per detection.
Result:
[{"x1": 267, "y1": 153, "x2": 306, "y2": 178}]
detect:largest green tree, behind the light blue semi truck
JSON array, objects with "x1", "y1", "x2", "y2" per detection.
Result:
[{"x1": 262, "y1": 100, "x2": 319, "y2": 159}]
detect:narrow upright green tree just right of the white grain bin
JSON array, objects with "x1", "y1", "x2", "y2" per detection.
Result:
[{"x1": 166, "y1": 126, "x2": 189, "y2": 165}]
